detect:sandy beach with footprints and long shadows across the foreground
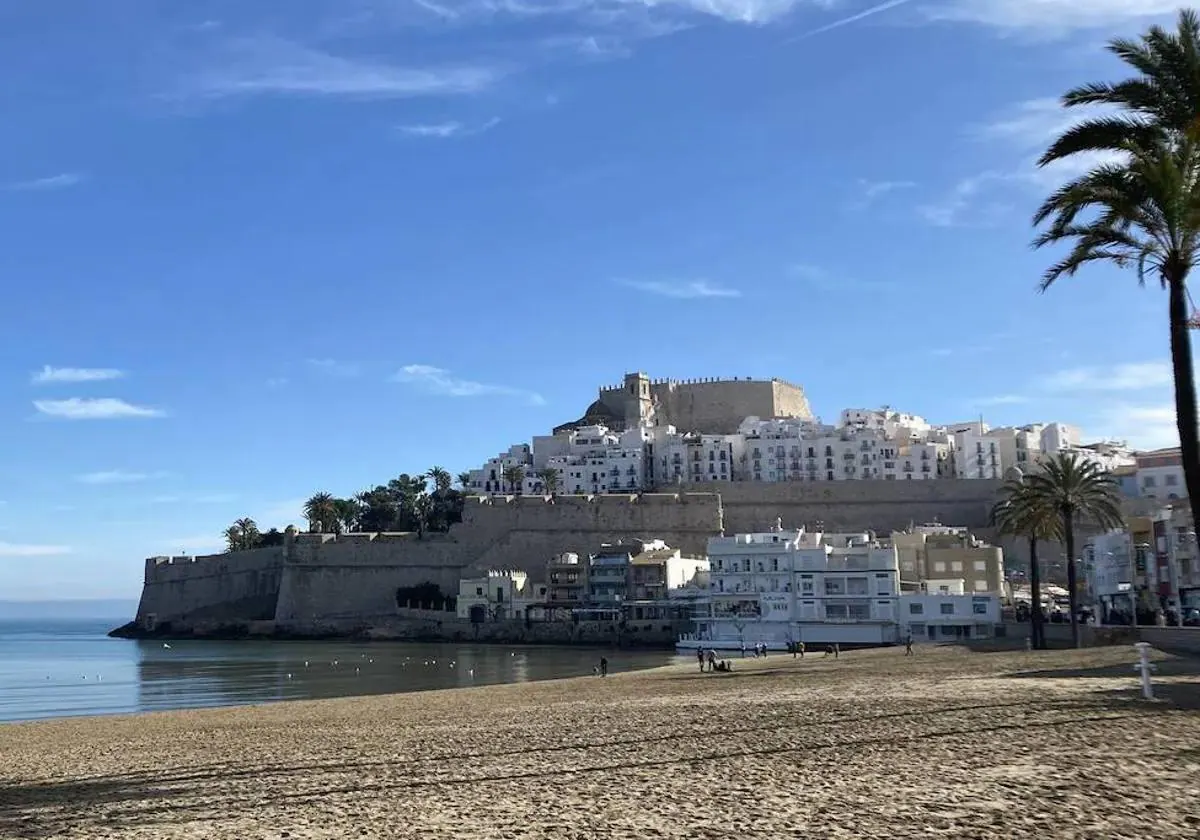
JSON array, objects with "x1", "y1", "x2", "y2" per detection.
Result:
[{"x1": 0, "y1": 647, "x2": 1200, "y2": 840}]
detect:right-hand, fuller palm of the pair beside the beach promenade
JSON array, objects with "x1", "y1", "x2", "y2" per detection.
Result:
[{"x1": 1026, "y1": 452, "x2": 1124, "y2": 647}]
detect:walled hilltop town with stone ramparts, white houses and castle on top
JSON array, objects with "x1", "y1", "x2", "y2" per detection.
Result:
[{"x1": 117, "y1": 373, "x2": 1118, "y2": 632}]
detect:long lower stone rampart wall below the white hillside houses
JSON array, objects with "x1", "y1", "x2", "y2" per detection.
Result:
[{"x1": 138, "y1": 480, "x2": 1000, "y2": 631}]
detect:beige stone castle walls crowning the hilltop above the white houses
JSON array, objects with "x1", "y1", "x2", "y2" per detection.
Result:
[{"x1": 599, "y1": 374, "x2": 812, "y2": 434}]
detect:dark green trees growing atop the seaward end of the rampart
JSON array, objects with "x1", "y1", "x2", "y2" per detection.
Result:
[{"x1": 224, "y1": 467, "x2": 470, "y2": 551}]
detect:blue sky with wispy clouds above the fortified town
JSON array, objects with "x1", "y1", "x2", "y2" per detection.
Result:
[{"x1": 0, "y1": 0, "x2": 1174, "y2": 598}]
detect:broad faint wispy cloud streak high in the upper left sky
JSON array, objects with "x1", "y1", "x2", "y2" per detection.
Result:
[{"x1": 182, "y1": 37, "x2": 504, "y2": 98}]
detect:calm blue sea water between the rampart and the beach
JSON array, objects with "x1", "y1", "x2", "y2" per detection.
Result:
[{"x1": 0, "y1": 619, "x2": 688, "y2": 721}]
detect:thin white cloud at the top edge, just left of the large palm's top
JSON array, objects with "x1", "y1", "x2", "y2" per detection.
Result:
[{"x1": 920, "y1": 0, "x2": 1181, "y2": 36}]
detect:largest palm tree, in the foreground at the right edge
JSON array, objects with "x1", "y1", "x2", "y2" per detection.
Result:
[{"x1": 1033, "y1": 10, "x2": 1200, "y2": 537}]
